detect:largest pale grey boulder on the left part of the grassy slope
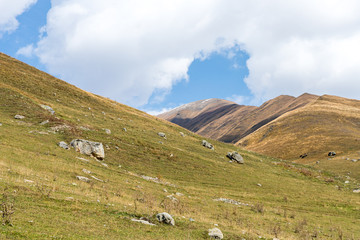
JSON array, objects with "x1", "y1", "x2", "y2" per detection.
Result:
[{"x1": 70, "y1": 139, "x2": 105, "y2": 160}]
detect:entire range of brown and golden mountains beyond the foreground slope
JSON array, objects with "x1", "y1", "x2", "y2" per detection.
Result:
[{"x1": 158, "y1": 93, "x2": 360, "y2": 160}]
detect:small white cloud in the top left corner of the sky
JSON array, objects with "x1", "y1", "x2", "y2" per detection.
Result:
[{"x1": 0, "y1": 0, "x2": 37, "y2": 37}]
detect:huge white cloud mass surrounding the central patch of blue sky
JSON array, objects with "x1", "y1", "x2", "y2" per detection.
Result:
[{"x1": 35, "y1": 0, "x2": 360, "y2": 106}]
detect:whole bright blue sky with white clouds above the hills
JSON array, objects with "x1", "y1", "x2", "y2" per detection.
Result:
[{"x1": 0, "y1": 0, "x2": 360, "y2": 113}]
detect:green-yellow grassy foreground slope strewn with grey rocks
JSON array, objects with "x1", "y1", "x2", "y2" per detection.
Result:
[{"x1": 0, "y1": 54, "x2": 360, "y2": 239}]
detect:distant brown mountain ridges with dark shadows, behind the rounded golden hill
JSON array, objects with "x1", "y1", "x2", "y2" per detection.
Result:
[{"x1": 158, "y1": 94, "x2": 318, "y2": 143}]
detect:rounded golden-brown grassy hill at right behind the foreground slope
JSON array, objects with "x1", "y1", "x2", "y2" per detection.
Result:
[{"x1": 238, "y1": 95, "x2": 360, "y2": 178}]
